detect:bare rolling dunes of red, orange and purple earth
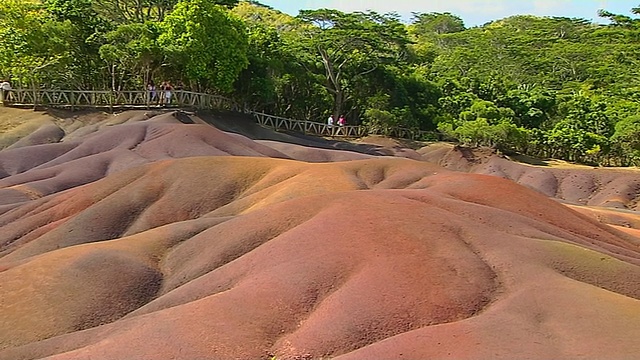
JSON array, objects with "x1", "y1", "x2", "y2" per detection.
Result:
[{"x1": 0, "y1": 108, "x2": 640, "y2": 360}]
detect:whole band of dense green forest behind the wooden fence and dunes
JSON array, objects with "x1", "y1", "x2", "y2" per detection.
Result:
[{"x1": 0, "y1": 0, "x2": 640, "y2": 166}]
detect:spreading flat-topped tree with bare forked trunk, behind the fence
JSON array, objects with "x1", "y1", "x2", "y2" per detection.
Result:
[{"x1": 290, "y1": 9, "x2": 409, "y2": 116}]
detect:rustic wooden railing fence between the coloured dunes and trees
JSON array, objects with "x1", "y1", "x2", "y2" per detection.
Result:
[{"x1": 0, "y1": 89, "x2": 439, "y2": 140}]
